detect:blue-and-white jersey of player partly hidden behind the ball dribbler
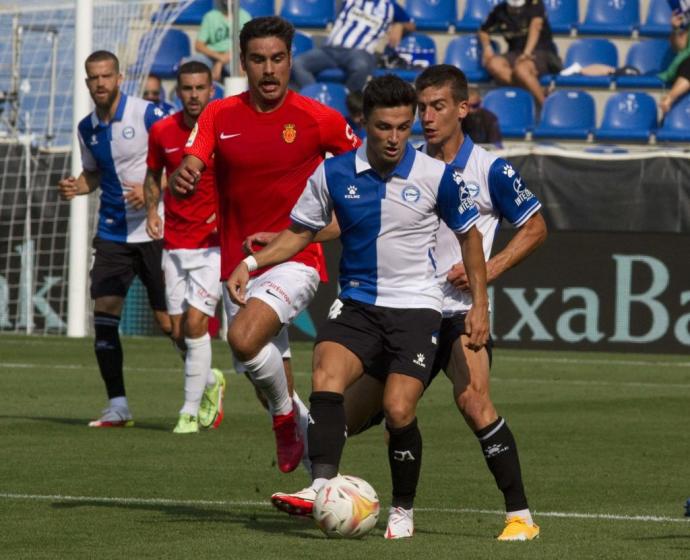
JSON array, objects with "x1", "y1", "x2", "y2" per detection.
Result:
[{"x1": 420, "y1": 135, "x2": 541, "y2": 316}]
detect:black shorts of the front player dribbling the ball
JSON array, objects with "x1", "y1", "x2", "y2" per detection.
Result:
[{"x1": 316, "y1": 299, "x2": 441, "y2": 386}]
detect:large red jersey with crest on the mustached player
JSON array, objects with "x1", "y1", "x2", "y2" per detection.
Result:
[{"x1": 185, "y1": 91, "x2": 361, "y2": 280}]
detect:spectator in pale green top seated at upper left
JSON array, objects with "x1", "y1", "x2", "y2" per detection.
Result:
[{"x1": 193, "y1": 0, "x2": 252, "y2": 82}]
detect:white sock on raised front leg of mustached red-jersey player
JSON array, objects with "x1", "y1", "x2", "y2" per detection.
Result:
[{"x1": 242, "y1": 342, "x2": 292, "y2": 416}]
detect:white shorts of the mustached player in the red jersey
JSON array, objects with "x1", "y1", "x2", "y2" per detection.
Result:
[{"x1": 223, "y1": 262, "x2": 320, "y2": 373}]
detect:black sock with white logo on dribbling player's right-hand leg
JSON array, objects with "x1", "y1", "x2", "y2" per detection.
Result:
[{"x1": 386, "y1": 418, "x2": 422, "y2": 509}]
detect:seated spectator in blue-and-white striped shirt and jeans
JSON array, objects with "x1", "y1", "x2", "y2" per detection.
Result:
[{"x1": 292, "y1": 0, "x2": 415, "y2": 91}]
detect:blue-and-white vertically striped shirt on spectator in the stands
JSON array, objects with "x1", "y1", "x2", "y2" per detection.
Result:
[{"x1": 326, "y1": 0, "x2": 410, "y2": 53}]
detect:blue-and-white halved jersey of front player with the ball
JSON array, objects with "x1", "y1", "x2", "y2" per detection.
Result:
[{"x1": 290, "y1": 142, "x2": 479, "y2": 311}]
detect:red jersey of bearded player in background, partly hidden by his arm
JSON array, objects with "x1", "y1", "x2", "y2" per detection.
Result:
[{"x1": 146, "y1": 111, "x2": 219, "y2": 249}]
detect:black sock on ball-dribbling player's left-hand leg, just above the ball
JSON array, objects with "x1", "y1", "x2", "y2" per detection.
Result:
[{"x1": 307, "y1": 391, "x2": 347, "y2": 479}]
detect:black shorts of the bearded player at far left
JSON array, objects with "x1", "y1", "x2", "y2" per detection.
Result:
[{"x1": 91, "y1": 237, "x2": 166, "y2": 311}]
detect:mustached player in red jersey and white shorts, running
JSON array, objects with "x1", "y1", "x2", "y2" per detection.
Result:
[{"x1": 170, "y1": 16, "x2": 360, "y2": 472}]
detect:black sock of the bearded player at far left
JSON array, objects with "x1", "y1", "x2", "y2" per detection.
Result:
[{"x1": 93, "y1": 311, "x2": 125, "y2": 399}]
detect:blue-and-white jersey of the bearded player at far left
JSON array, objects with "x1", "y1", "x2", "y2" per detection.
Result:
[{"x1": 78, "y1": 93, "x2": 165, "y2": 243}]
